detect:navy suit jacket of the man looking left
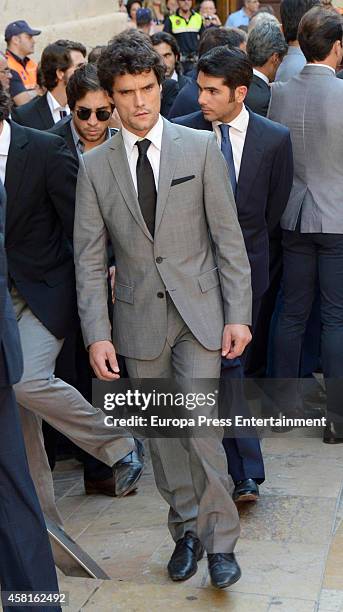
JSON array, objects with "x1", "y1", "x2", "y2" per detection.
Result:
[{"x1": 173, "y1": 111, "x2": 293, "y2": 299}]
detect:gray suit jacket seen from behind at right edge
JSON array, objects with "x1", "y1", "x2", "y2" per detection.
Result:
[{"x1": 268, "y1": 65, "x2": 343, "y2": 234}]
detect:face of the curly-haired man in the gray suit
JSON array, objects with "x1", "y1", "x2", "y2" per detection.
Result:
[{"x1": 112, "y1": 69, "x2": 161, "y2": 138}]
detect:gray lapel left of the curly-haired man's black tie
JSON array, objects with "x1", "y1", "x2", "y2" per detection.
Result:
[{"x1": 108, "y1": 132, "x2": 153, "y2": 241}]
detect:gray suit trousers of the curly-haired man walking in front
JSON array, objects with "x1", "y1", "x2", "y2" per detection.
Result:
[{"x1": 125, "y1": 296, "x2": 239, "y2": 553}]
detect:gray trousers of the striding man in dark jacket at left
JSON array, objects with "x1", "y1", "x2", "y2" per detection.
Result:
[{"x1": 11, "y1": 289, "x2": 135, "y2": 525}]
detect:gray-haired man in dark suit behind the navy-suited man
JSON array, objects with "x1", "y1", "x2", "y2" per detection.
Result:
[{"x1": 245, "y1": 22, "x2": 287, "y2": 117}]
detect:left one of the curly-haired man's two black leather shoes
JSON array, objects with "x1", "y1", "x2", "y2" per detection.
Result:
[{"x1": 168, "y1": 531, "x2": 204, "y2": 582}]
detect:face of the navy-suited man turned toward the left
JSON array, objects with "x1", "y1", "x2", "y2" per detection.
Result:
[{"x1": 197, "y1": 72, "x2": 247, "y2": 123}]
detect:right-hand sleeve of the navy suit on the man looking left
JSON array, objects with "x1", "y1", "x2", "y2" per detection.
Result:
[{"x1": 266, "y1": 132, "x2": 293, "y2": 235}]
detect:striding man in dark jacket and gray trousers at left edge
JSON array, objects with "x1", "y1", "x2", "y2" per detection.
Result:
[{"x1": 4, "y1": 97, "x2": 142, "y2": 523}]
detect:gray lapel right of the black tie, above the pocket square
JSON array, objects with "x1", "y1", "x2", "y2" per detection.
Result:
[{"x1": 155, "y1": 120, "x2": 182, "y2": 235}]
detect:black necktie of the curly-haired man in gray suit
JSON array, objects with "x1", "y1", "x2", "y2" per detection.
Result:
[{"x1": 136, "y1": 138, "x2": 156, "y2": 236}]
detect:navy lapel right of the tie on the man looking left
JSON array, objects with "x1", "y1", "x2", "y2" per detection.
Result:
[{"x1": 236, "y1": 111, "x2": 264, "y2": 209}]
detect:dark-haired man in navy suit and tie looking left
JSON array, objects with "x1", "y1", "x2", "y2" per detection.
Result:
[{"x1": 174, "y1": 47, "x2": 293, "y2": 500}]
